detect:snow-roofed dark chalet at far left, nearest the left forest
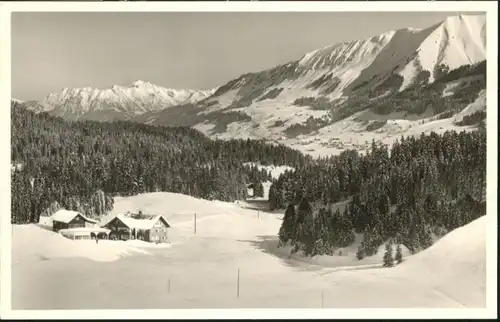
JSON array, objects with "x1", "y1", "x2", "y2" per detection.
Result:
[{"x1": 50, "y1": 209, "x2": 109, "y2": 239}]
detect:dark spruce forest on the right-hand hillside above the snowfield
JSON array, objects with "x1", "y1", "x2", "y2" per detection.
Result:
[{"x1": 269, "y1": 128, "x2": 486, "y2": 259}]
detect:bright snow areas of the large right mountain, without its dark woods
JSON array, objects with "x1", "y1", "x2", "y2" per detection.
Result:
[{"x1": 187, "y1": 14, "x2": 486, "y2": 156}]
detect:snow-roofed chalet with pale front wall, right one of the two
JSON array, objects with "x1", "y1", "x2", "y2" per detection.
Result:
[{"x1": 103, "y1": 214, "x2": 170, "y2": 243}]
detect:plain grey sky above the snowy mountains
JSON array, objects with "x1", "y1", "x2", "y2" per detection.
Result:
[{"x1": 12, "y1": 12, "x2": 472, "y2": 100}]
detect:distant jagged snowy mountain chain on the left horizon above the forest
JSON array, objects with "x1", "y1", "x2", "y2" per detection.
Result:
[{"x1": 27, "y1": 80, "x2": 215, "y2": 121}]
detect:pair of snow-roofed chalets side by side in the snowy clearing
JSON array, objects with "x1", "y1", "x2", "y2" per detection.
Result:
[{"x1": 50, "y1": 209, "x2": 170, "y2": 243}]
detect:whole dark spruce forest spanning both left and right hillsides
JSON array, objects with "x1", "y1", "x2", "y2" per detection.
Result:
[{"x1": 11, "y1": 102, "x2": 486, "y2": 259}]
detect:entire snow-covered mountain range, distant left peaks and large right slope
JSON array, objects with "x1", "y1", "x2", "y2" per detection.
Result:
[{"x1": 17, "y1": 15, "x2": 486, "y2": 154}]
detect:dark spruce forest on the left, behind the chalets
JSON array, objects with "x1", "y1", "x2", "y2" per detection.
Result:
[{"x1": 11, "y1": 102, "x2": 311, "y2": 223}]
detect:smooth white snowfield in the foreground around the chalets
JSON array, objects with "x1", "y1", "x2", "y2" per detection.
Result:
[{"x1": 12, "y1": 193, "x2": 486, "y2": 309}]
